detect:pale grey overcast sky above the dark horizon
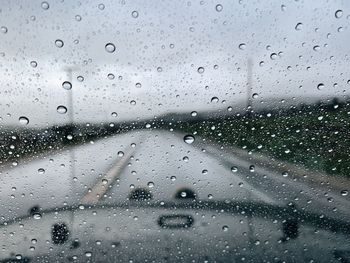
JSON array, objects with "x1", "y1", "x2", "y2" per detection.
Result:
[{"x1": 0, "y1": 0, "x2": 350, "y2": 127}]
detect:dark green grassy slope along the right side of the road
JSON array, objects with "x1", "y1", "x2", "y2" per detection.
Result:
[{"x1": 174, "y1": 108, "x2": 350, "y2": 178}]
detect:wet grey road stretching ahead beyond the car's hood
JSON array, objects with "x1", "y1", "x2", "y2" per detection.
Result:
[{"x1": 0, "y1": 130, "x2": 350, "y2": 222}]
